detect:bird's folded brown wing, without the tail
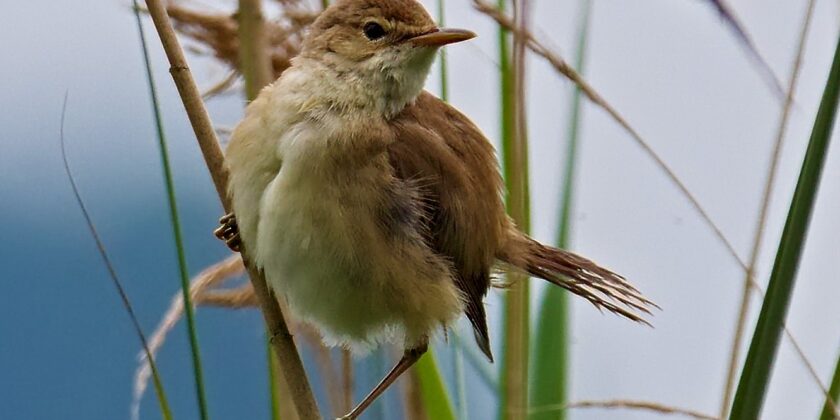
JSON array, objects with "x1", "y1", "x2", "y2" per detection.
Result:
[{"x1": 388, "y1": 92, "x2": 507, "y2": 361}]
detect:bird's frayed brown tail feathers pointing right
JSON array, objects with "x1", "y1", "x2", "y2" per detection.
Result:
[{"x1": 497, "y1": 229, "x2": 659, "y2": 325}]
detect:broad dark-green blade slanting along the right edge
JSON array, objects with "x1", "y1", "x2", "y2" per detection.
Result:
[{"x1": 729, "y1": 32, "x2": 840, "y2": 420}]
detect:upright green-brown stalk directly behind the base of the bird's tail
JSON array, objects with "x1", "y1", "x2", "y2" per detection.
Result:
[{"x1": 498, "y1": 0, "x2": 530, "y2": 420}]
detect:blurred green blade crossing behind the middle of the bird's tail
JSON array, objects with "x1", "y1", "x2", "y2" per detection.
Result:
[{"x1": 528, "y1": 0, "x2": 592, "y2": 420}]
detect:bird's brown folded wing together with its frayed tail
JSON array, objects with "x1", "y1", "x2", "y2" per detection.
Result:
[{"x1": 387, "y1": 92, "x2": 652, "y2": 361}]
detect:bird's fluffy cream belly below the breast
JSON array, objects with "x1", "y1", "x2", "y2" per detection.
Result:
[{"x1": 256, "y1": 171, "x2": 460, "y2": 348}]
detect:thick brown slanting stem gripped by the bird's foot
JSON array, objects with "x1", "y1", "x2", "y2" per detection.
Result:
[{"x1": 141, "y1": 0, "x2": 318, "y2": 420}]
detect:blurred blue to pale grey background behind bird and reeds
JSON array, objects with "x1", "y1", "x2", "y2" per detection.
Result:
[{"x1": 0, "y1": 0, "x2": 840, "y2": 419}]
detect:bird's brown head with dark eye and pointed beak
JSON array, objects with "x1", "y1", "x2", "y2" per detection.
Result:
[{"x1": 301, "y1": 0, "x2": 475, "y2": 113}]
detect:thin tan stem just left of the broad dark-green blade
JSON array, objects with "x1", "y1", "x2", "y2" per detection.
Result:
[{"x1": 720, "y1": 0, "x2": 821, "y2": 418}]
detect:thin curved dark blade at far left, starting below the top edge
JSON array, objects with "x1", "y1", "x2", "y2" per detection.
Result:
[{"x1": 59, "y1": 94, "x2": 172, "y2": 420}]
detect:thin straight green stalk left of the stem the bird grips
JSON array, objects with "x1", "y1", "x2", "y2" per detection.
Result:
[{"x1": 134, "y1": 0, "x2": 209, "y2": 420}]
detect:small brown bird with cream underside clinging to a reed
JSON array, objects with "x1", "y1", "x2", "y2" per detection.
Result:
[{"x1": 217, "y1": 0, "x2": 653, "y2": 418}]
